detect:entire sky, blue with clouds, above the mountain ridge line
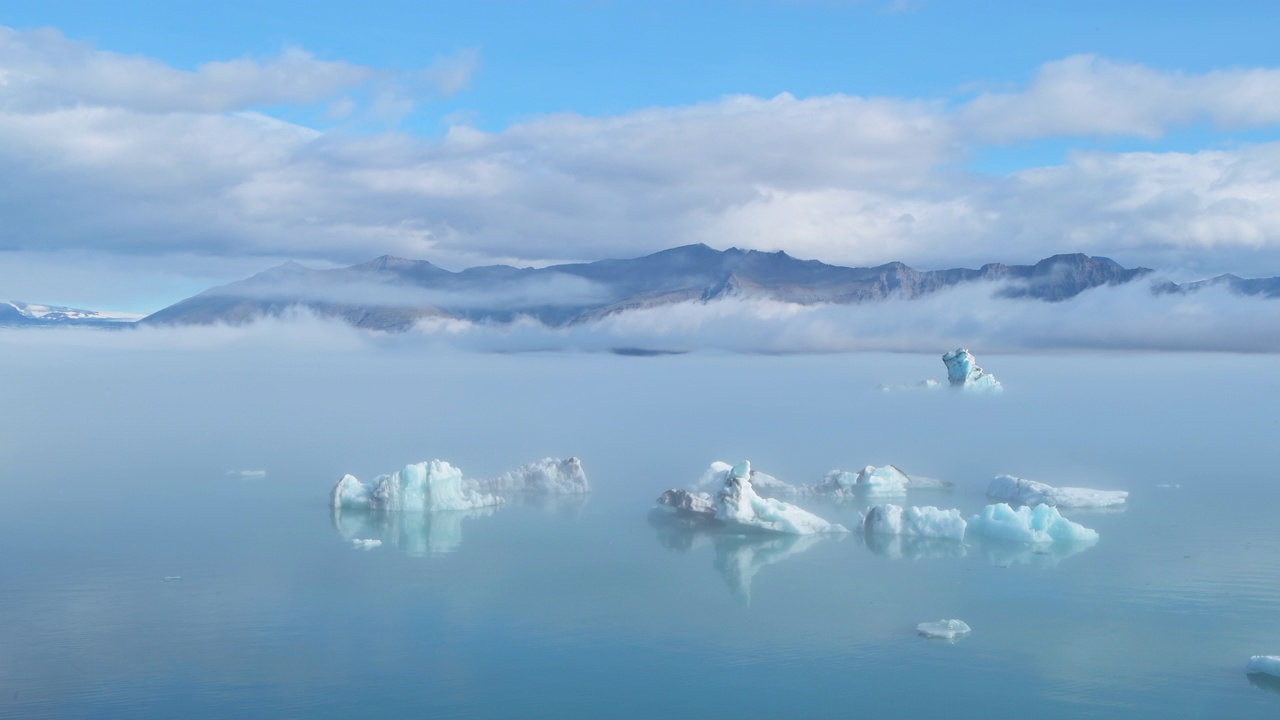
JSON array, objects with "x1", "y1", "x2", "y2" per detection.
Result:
[{"x1": 0, "y1": 0, "x2": 1280, "y2": 311}]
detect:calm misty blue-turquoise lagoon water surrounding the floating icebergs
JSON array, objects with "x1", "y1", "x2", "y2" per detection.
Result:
[{"x1": 0, "y1": 341, "x2": 1280, "y2": 717}]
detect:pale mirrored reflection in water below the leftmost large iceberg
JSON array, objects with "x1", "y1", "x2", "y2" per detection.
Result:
[{"x1": 332, "y1": 507, "x2": 494, "y2": 557}]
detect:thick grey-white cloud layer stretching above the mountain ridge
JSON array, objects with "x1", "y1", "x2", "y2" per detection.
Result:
[{"x1": 0, "y1": 23, "x2": 1280, "y2": 307}]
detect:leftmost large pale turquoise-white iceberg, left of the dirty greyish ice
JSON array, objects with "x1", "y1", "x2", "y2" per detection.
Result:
[{"x1": 330, "y1": 460, "x2": 502, "y2": 512}]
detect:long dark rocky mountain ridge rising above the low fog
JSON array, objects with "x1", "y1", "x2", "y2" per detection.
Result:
[{"x1": 135, "y1": 245, "x2": 1167, "y2": 331}]
